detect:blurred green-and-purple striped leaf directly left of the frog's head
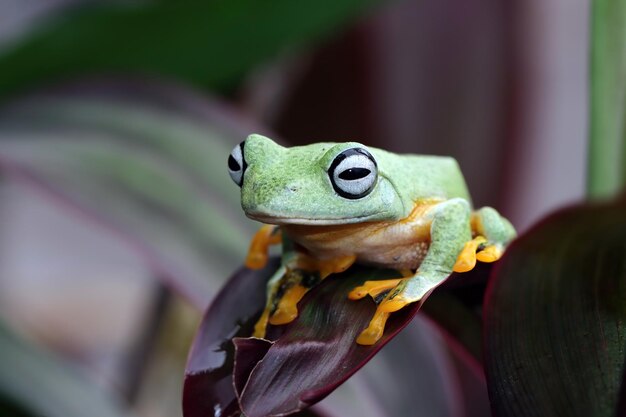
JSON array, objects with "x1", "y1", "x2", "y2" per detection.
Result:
[{"x1": 0, "y1": 81, "x2": 256, "y2": 308}]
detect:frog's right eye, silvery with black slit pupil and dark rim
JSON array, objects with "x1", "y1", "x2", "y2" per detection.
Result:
[{"x1": 328, "y1": 148, "x2": 378, "y2": 199}]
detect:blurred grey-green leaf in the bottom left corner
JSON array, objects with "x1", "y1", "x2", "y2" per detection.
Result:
[{"x1": 0, "y1": 322, "x2": 131, "y2": 417}]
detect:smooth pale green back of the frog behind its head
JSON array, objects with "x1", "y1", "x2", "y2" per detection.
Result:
[{"x1": 370, "y1": 148, "x2": 471, "y2": 211}]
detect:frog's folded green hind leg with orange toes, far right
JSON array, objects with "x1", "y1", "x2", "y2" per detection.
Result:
[{"x1": 471, "y1": 207, "x2": 516, "y2": 262}]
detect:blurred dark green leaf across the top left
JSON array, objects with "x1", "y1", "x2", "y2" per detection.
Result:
[{"x1": 0, "y1": 0, "x2": 377, "y2": 96}]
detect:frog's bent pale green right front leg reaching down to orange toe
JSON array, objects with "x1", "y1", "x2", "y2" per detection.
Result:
[{"x1": 357, "y1": 198, "x2": 472, "y2": 345}]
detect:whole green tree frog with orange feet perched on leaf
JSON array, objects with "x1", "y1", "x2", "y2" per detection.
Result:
[{"x1": 228, "y1": 134, "x2": 515, "y2": 345}]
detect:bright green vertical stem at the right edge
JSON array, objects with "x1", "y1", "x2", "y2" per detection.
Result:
[{"x1": 587, "y1": 0, "x2": 626, "y2": 197}]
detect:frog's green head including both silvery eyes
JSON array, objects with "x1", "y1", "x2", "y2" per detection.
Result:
[{"x1": 228, "y1": 135, "x2": 403, "y2": 225}]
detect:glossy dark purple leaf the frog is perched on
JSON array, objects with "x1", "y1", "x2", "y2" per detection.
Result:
[{"x1": 184, "y1": 256, "x2": 492, "y2": 417}]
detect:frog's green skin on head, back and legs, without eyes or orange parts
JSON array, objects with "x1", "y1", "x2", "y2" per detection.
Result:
[{"x1": 234, "y1": 134, "x2": 515, "y2": 316}]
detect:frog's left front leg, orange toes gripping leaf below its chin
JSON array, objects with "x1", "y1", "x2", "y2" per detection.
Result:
[{"x1": 253, "y1": 252, "x2": 356, "y2": 338}]
